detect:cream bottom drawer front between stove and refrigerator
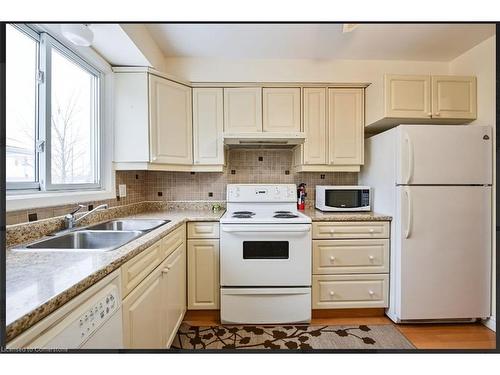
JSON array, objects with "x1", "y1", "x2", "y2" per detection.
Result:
[{"x1": 312, "y1": 274, "x2": 389, "y2": 309}]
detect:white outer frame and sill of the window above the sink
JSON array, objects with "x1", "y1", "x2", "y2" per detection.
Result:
[{"x1": 6, "y1": 24, "x2": 116, "y2": 212}]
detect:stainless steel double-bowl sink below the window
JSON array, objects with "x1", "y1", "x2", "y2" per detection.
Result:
[{"x1": 13, "y1": 219, "x2": 170, "y2": 251}]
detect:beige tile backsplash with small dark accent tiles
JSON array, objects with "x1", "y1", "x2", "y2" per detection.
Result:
[{"x1": 6, "y1": 149, "x2": 358, "y2": 224}]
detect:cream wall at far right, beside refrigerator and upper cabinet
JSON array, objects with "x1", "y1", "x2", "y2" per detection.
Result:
[{"x1": 449, "y1": 36, "x2": 497, "y2": 327}]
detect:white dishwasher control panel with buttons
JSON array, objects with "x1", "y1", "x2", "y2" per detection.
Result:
[{"x1": 78, "y1": 287, "x2": 120, "y2": 343}]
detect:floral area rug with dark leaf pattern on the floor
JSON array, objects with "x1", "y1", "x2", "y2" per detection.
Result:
[{"x1": 171, "y1": 323, "x2": 415, "y2": 350}]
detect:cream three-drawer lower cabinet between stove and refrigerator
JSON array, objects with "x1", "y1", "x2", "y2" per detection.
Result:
[{"x1": 312, "y1": 221, "x2": 390, "y2": 309}]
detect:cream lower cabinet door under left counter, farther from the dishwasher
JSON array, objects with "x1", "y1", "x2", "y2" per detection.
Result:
[{"x1": 162, "y1": 244, "x2": 186, "y2": 348}]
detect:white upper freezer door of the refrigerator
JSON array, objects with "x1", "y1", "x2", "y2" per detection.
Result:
[{"x1": 396, "y1": 125, "x2": 493, "y2": 185}]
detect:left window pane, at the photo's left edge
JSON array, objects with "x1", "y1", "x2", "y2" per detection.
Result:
[{"x1": 6, "y1": 25, "x2": 38, "y2": 183}]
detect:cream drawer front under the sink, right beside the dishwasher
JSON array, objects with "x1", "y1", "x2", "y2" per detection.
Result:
[{"x1": 121, "y1": 241, "x2": 162, "y2": 298}]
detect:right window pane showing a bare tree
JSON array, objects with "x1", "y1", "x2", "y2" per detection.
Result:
[{"x1": 51, "y1": 48, "x2": 99, "y2": 184}]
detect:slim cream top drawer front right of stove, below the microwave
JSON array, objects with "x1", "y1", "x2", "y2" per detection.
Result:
[{"x1": 313, "y1": 221, "x2": 389, "y2": 239}]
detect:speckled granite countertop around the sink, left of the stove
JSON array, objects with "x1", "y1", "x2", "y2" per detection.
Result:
[{"x1": 6, "y1": 209, "x2": 225, "y2": 341}]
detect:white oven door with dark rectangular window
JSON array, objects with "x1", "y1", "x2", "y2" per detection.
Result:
[{"x1": 220, "y1": 224, "x2": 311, "y2": 287}]
